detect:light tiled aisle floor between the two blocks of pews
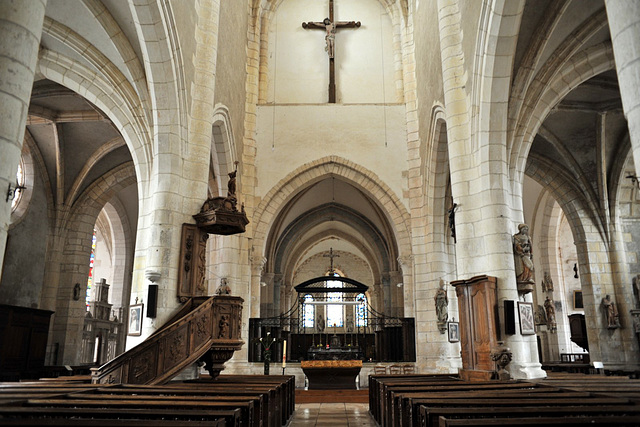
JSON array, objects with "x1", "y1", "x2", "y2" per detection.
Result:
[{"x1": 289, "y1": 403, "x2": 378, "y2": 427}]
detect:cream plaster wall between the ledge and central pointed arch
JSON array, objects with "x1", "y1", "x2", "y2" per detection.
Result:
[{"x1": 255, "y1": 104, "x2": 407, "y2": 200}]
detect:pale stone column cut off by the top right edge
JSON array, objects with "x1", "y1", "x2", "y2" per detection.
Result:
[{"x1": 605, "y1": 0, "x2": 640, "y2": 175}]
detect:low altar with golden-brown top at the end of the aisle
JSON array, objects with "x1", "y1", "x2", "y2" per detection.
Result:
[{"x1": 300, "y1": 360, "x2": 362, "y2": 390}]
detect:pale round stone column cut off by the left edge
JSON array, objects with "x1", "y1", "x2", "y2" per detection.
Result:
[{"x1": 0, "y1": 0, "x2": 46, "y2": 280}]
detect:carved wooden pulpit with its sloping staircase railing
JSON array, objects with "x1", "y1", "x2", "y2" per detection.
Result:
[{"x1": 91, "y1": 295, "x2": 244, "y2": 385}]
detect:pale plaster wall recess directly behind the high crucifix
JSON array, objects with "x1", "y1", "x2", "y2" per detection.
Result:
[{"x1": 267, "y1": 0, "x2": 395, "y2": 103}]
